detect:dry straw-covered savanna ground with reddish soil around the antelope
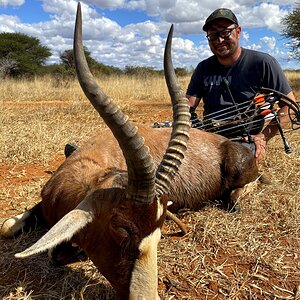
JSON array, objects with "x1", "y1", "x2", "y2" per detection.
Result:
[{"x1": 0, "y1": 72, "x2": 300, "y2": 300}]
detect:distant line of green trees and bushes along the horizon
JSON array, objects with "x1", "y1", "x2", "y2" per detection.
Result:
[{"x1": 0, "y1": 32, "x2": 189, "y2": 79}]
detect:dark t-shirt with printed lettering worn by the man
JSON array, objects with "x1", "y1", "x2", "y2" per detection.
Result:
[{"x1": 187, "y1": 48, "x2": 292, "y2": 135}]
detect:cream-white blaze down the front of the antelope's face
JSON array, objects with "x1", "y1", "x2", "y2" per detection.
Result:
[{"x1": 129, "y1": 228, "x2": 161, "y2": 300}]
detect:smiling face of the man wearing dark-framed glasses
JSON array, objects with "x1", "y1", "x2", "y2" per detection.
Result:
[{"x1": 207, "y1": 19, "x2": 241, "y2": 58}]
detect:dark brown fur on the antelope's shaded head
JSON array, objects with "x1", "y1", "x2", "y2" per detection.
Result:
[{"x1": 72, "y1": 188, "x2": 167, "y2": 299}]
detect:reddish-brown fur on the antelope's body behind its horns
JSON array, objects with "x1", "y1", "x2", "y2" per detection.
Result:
[{"x1": 46, "y1": 127, "x2": 258, "y2": 217}]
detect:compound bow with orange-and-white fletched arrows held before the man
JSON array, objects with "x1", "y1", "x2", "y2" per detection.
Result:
[{"x1": 152, "y1": 87, "x2": 300, "y2": 153}]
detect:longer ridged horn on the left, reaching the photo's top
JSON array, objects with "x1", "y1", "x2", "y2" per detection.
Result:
[{"x1": 74, "y1": 3, "x2": 155, "y2": 203}]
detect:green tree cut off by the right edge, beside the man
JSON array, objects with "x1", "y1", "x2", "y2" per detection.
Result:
[{"x1": 282, "y1": 7, "x2": 300, "y2": 60}]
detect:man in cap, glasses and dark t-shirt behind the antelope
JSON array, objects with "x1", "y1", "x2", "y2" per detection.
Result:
[{"x1": 187, "y1": 8, "x2": 295, "y2": 162}]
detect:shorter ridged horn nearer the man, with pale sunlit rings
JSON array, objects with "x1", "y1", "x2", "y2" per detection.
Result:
[{"x1": 156, "y1": 25, "x2": 190, "y2": 195}]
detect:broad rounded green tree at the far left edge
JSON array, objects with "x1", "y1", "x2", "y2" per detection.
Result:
[{"x1": 0, "y1": 32, "x2": 51, "y2": 77}]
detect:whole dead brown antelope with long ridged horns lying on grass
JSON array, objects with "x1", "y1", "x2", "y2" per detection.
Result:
[{"x1": 0, "y1": 1, "x2": 258, "y2": 299}]
